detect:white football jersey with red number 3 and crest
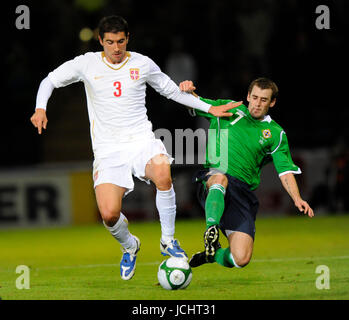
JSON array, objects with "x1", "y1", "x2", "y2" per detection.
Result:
[{"x1": 48, "y1": 52, "x2": 208, "y2": 157}]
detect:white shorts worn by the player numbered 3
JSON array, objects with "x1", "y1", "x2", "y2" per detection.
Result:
[{"x1": 93, "y1": 139, "x2": 174, "y2": 196}]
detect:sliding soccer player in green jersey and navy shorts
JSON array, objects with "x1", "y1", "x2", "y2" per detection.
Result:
[{"x1": 180, "y1": 78, "x2": 314, "y2": 268}]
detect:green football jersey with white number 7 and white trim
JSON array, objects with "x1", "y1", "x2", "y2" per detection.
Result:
[{"x1": 195, "y1": 98, "x2": 301, "y2": 190}]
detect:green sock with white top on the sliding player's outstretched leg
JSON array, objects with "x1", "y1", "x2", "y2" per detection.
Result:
[{"x1": 205, "y1": 183, "x2": 225, "y2": 228}]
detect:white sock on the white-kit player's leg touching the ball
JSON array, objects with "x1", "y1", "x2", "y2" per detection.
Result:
[{"x1": 155, "y1": 185, "x2": 176, "y2": 242}]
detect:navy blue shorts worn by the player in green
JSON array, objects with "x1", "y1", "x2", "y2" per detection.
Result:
[{"x1": 195, "y1": 169, "x2": 259, "y2": 239}]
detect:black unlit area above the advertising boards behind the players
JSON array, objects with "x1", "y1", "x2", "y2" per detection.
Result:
[{"x1": 0, "y1": 0, "x2": 349, "y2": 169}]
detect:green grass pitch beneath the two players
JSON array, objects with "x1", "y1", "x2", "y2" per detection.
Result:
[{"x1": 0, "y1": 215, "x2": 349, "y2": 300}]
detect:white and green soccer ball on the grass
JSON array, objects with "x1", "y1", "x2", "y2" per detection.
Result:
[{"x1": 158, "y1": 257, "x2": 193, "y2": 290}]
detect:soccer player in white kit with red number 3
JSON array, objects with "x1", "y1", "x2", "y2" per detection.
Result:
[{"x1": 31, "y1": 16, "x2": 239, "y2": 280}]
